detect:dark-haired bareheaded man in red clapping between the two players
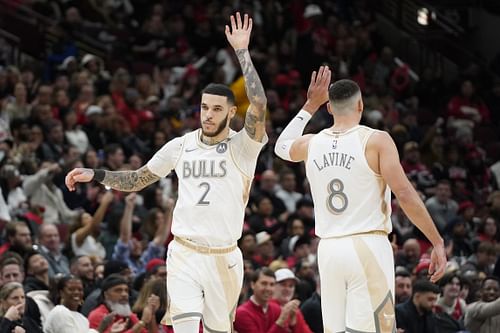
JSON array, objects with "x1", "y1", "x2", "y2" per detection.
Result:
[{"x1": 234, "y1": 267, "x2": 303, "y2": 333}]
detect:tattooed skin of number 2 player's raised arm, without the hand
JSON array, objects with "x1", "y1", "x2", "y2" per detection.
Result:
[{"x1": 236, "y1": 49, "x2": 267, "y2": 140}]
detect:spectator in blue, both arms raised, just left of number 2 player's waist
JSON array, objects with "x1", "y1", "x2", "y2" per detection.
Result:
[{"x1": 113, "y1": 193, "x2": 170, "y2": 276}]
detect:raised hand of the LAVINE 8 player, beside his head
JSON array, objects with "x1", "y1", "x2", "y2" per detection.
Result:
[{"x1": 303, "y1": 66, "x2": 332, "y2": 114}]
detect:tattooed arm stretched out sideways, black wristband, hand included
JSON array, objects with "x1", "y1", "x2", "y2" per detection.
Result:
[{"x1": 66, "y1": 165, "x2": 160, "y2": 192}]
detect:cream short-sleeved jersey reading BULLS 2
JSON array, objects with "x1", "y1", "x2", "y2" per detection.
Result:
[{"x1": 147, "y1": 129, "x2": 267, "y2": 247}]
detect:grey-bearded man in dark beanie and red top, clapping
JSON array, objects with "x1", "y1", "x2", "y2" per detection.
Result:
[{"x1": 88, "y1": 274, "x2": 153, "y2": 333}]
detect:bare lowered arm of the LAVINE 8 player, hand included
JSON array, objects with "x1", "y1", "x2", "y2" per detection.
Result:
[{"x1": 374, "y1": 132, "x2": 446, "y2": 282}]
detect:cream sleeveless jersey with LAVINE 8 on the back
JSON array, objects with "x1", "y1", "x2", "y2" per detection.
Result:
[{"x1": 306, "y1": 126, "x2": 392, "y2": 238}]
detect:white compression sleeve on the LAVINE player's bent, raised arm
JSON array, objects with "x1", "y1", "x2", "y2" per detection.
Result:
[{"x1": 274, "y1": 110, "x2": 312, "y2": 162}]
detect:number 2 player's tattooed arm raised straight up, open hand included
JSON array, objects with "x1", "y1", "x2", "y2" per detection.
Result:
[{"x1": 226, "y1": 13, "x2": 267, "y2": 142}]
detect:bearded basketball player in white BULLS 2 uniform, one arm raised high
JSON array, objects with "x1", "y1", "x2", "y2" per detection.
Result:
[{"x1": 66, "y1": 13, "x2": 267, "y2": 333}]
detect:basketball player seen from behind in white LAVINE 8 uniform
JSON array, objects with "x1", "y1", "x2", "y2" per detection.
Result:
[{"x1": 275, "y1": 67, "x2": 446, "y2": 333}]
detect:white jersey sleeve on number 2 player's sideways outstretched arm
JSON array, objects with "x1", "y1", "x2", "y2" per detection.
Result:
[{"x1": 147, "y1": 137, "x2": 184, "y2": 178}]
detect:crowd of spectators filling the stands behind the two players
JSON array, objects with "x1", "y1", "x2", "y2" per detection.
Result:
[{"x1": 0, "y1": 0, "x2": 500, "y2": 333}]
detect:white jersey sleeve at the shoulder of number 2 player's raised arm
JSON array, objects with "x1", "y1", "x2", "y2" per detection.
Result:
[{"x1": 230, "y1": 128, "x2": 268, "y2": 178}]
